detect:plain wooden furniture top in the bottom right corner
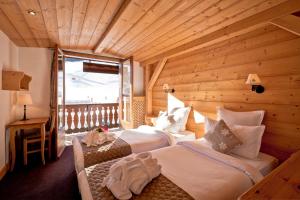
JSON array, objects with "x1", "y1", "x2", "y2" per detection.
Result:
[{"x1": 239, "y1": 151, "x2": 300, "y2": 200}]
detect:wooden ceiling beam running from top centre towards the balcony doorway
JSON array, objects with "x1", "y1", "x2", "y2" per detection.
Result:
[{"x1": 94, "y1": 0, "x2": 131, "y2": 53}]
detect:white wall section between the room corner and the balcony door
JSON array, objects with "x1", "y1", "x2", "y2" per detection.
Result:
[{"x1": 17, "y1": 47, "x2": 52, "y2": 118}]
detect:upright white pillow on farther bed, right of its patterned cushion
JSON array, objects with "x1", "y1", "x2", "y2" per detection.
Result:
[{"x1": 169, "y1": 107, "x2": 191, "y2": 133}]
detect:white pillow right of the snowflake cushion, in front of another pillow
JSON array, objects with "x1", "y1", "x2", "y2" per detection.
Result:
[{"x1": 230, "y1": 125, "x2": 265, "y2": 159}]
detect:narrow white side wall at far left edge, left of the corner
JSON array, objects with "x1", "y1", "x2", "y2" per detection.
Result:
[{"x1": 0, "y1": 31, "x2": 19, "y2": 169}]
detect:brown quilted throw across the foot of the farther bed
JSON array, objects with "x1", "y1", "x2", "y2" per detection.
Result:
[{"x1": 80, "y1": 138, "x2": 132, "y2": 167}]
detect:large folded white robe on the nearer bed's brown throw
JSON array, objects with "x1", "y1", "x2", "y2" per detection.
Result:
[{"x1": 102, "y1": 152, "x2": 161, "y2": 199}]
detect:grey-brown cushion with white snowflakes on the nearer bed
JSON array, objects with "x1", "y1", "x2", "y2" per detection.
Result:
[{"x1": 204, "y1": 120, "x2": 242, "y2": 153}]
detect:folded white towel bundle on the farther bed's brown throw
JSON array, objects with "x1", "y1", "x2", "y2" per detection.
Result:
[{"x1": 81, "y1": 130, "x2": 115, "y2": 147}]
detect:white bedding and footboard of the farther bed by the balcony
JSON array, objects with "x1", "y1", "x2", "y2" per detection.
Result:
[{"x1": 73, "y1": 125, "x2": 195, "y2": 173}]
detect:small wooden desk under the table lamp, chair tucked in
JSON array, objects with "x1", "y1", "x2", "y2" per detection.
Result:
[{"x1": 6, "y1": 118, "x2": 48, "y2": 171}]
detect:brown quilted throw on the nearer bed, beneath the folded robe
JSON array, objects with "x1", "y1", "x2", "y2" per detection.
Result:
[{"x1": 79, "y1": 159, "x2": 193, "y2": 200}]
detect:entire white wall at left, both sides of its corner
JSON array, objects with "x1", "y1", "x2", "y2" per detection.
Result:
[{"x1": 0, "y1": 31, "x2": 52, "y2": 170}]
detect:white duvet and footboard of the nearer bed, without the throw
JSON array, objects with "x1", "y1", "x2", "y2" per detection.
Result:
[{"x1": 78, "y1": 141, "x2": 276, "y2": 200}]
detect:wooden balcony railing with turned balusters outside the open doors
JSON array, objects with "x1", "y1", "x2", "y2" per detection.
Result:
[{"x1": 59, "y1": 103, "x2": 119, "y2": 133}]
